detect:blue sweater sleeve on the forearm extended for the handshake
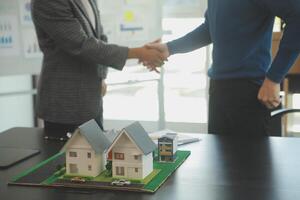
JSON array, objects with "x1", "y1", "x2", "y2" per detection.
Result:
[{"x1": 167, "y1": 13, "x2": 212, "y2": 55}]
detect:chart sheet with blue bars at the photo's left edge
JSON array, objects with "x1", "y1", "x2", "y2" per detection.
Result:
[{"x1": 0, "y1": 15, "x2": 20, "y2": 56}]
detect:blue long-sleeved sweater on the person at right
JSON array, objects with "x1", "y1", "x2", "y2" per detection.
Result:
[{"x1": 167, "y1": 0, "x2": 300, "y2": 83}]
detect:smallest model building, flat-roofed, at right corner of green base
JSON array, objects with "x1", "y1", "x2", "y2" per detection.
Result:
[{"x1": 158, "y1": 133, "x2": 178, "y2": 162}]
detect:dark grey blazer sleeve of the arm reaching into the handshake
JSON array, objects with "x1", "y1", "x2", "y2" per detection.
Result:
[{"x1": 32, "y1": 0, "x2": 128, "y2": 70}]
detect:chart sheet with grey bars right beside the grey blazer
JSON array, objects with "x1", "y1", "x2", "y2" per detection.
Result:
[{"x1": 23, "y1": 29, "x2": 43, "y2": 58}]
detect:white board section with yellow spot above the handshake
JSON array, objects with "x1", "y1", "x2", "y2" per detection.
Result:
[{"x1": 98, "y1": 0, "x2": 162, "y2": 47}]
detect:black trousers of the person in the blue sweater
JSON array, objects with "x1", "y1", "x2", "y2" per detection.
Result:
[{"x1": 208, "y1": 79, "x2": 270, "y2": 136}]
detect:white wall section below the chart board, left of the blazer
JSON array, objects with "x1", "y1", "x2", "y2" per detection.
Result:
[{"x1": 0, "y1": 75, "x2": 34, "y2": 132}]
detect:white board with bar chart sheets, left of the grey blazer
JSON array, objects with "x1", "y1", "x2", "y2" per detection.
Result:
[{"x1": 0, "y1": 0, "x2": 42, "y2": 76}]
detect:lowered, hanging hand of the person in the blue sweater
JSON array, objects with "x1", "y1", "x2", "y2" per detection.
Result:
[{"x1": 258, "y1": 78, "x2": 281, "y2": 109}]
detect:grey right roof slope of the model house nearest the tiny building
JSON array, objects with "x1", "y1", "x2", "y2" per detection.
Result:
[{"x1": 124, "y1": 122, "x2": 156, "y2": 155}]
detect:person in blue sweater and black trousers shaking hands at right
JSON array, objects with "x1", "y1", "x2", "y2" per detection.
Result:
[{"x1": 144, "y1": 0, "x2": 300, "y2": 135}]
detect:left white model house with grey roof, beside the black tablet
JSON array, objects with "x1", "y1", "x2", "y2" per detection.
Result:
[{"x1": 62, "y1": 120, "x2": 112, "y2": 177}]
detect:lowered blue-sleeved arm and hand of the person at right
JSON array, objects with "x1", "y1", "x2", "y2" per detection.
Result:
[{"x1": 253, "y1": 0, "x2": 300, "y2": 109}]
